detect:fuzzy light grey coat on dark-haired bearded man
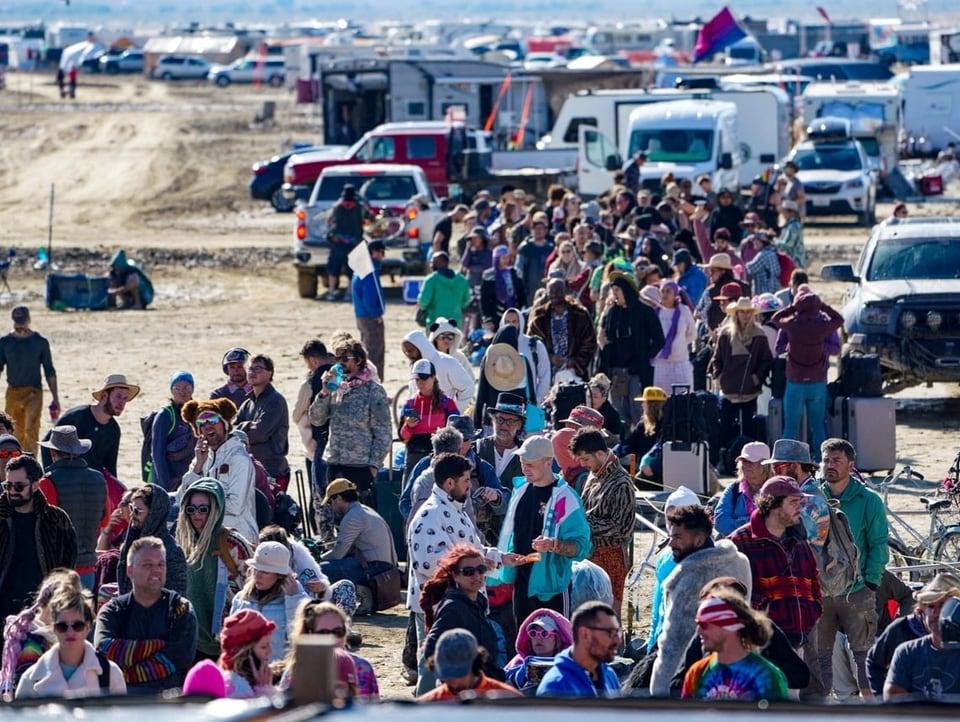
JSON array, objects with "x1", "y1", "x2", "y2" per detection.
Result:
[{"x1": 650, "y1": 539, "x2": 753, "y2": 697}]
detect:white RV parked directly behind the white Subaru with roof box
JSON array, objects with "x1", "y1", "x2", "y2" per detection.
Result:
[{"x1": 802, "y1": 80, "x2": 900, "y2": 178}]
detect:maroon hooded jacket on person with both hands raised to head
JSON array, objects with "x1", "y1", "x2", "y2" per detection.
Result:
[{"x1": 770, "y1": 291, "x2": 843, "y2": 383}]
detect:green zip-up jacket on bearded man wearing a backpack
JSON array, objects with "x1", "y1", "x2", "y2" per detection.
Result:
[{"x1": 821, "y1": 479, "x2": 890, "y2": 594}]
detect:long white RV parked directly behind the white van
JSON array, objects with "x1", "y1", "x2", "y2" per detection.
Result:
[{"x1": 537, "y1": 86, "x2": 791, "y2": 185}]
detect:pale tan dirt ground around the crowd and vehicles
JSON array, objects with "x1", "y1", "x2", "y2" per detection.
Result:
[{"x1": 0, "y1": 73, "x2": 960, "y2": 697}]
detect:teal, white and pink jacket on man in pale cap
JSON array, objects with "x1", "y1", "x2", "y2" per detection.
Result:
[{"x1": 498, "y1": 477, "x2": 592, "y2": 601}]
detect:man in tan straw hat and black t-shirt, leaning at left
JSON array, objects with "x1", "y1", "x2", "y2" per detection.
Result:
[{"x1": 40, "y1": 374, "x2": 140, "y2": 478}]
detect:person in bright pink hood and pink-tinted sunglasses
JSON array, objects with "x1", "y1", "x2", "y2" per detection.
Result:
[{"x1": 504, "y1": 609, "x2": 573, "y2": 695}]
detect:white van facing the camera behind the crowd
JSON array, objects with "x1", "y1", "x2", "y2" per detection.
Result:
[{"x1": 623, "y1": 100, "x2": 742, "y2": 190}]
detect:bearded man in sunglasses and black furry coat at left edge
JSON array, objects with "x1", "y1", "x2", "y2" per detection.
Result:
[{"x1": 0, "y1": 456, "x2": 77, "y2": 619}]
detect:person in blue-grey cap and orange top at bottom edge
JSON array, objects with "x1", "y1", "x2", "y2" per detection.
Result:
[{"x1": 417, "y1": 629, "x2": 520, "y2": 702}]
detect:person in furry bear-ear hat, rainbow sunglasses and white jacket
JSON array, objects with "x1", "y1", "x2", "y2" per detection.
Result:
[{"x1": 179, "y1": 398, "x2": 259, "y2": 541}]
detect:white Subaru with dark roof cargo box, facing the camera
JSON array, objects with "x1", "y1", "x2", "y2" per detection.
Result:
[{"x1": 787, "y1": 119, "x2": 877, "y2": 228}]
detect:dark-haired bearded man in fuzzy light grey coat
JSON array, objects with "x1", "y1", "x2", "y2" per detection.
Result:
[{"x1": 650, "y1": 504, "x2": 752, "y2": 697}]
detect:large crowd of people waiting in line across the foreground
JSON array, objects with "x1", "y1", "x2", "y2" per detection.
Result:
[{"x1": 0, "y1": 172, "x2": 944, "y2": 702}]
